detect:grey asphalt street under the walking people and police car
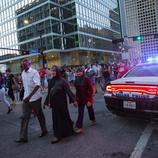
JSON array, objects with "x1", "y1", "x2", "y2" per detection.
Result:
[{"x1": 0, "y1": 90, "x2": 158, "y2": 158}]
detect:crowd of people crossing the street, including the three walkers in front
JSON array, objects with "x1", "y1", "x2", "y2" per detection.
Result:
[{"x1": 0, "y1": 59, "x2": 129, "y2": 143}]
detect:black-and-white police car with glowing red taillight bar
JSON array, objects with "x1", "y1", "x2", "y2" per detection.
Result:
[{"x1": 104, "y1": 63, "x2": 158, "y2": 117}]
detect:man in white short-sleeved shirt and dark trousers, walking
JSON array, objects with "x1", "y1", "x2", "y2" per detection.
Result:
[{"x1": 16, "y1": 59, "x2": 47, "y2": 143}]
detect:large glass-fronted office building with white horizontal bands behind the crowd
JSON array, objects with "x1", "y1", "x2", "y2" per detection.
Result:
[{"x1": 0, "y1": 0, "x2": 121, "y2": 71}]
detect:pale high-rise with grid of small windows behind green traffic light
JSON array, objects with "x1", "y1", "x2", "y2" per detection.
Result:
[{"x1": 125, "y1": 0, "x2": 158, "y2": 61}]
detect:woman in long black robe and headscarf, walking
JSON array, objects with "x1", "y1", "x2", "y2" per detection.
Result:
[{"x1": 44, "y1": 66, "x2": 77, "y2": 144}]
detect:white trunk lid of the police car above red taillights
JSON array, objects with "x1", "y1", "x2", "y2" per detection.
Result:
[{"x1": 111, "y1": 76, "x2": 158, "y2": 85}]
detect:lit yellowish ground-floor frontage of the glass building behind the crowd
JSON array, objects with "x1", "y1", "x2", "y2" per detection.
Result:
[{"x1": 5, "y1": 51, "x2": 120, "y2": 73}]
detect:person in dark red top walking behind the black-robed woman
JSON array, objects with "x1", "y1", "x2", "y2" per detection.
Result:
[{"x1": 74, "y1": 68, "x2": 95, "y2": 133}]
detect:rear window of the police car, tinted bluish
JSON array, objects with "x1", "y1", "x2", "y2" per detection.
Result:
[{"x1": 125, "y1": 64, "x2": 158, "y2": 77}]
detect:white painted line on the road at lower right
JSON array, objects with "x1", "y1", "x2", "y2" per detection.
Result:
[{"x1": 130, "y1": 124, "x2": 153, "y2": 158}]
